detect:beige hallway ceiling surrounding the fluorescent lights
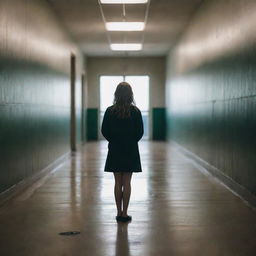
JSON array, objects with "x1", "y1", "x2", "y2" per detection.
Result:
[{"x1": 48, "y1": 0, "x2": 202, "y2": 56}]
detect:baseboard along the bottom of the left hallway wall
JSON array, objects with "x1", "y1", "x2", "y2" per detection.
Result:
[{"x1": 0, "y1": 151, "x2": 72, "y2": 206}]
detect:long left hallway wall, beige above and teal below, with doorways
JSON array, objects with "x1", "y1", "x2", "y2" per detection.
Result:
[{"x1": 0, "y1": 0, "x2": 82, "y2": 192}]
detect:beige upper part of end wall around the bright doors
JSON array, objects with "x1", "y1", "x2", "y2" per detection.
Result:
[{"x1": 87, "y1": 57, "x2": 166, "y2": 138}]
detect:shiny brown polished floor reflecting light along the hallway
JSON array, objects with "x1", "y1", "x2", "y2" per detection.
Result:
[{"x1": 0, "y1": 142, "x2": 256, "y2": 256}]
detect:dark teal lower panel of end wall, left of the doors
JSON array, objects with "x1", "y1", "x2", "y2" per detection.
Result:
[{"x1": 86, "y1": 108, "x2": 98, "y2": 141}]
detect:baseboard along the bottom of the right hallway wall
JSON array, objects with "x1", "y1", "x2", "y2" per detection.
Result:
[{"x1": 171, "y1": 141, "x2": 256, "y2": 210}]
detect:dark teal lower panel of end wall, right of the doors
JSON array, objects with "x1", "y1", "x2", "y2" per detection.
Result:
[{"x1": 152, "y1": 108, "x2": 166, "y2": 140}]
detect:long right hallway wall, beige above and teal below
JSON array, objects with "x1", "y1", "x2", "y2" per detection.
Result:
[{"x1": 167, "y1": 0, "x2": 256, "y2": 195}]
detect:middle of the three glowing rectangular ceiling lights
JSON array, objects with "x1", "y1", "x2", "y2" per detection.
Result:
[{"x1": 106, "y1": 22, "x2": 145, "y2": 31}]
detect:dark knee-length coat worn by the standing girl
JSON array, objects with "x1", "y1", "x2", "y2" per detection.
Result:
[{"x1": 101, "y1": 106, "x2": 143, "y2": 172}]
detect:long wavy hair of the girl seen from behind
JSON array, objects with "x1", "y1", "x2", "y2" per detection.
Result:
[{"x1": 113, "y1": 82, "x2": 135, "y2": 118}]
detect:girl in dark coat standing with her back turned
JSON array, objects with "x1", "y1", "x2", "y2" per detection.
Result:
[{"x1": 101, "y1": 82, "x2": 143, "y2": 222}]
